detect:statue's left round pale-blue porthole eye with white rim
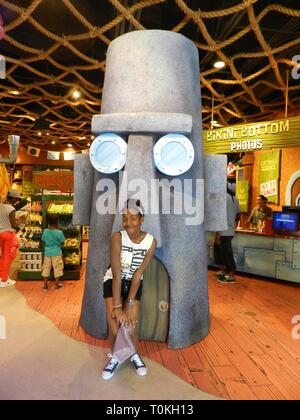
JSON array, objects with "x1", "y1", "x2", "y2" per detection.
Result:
[{"x1": 90, "y1": 133, "x2": 127, "y2": 174}]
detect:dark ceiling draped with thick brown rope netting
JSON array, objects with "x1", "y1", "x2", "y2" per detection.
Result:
[{"x1": 0, "y1": 0, "x2": 300, "y2": 150}]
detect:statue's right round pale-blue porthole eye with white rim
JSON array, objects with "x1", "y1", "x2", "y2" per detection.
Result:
[{"x1": 153, "y1": 134, "x2": 195, "y2": 176}]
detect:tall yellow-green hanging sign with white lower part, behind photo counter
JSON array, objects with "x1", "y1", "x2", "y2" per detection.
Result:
[{"x1": 259, "y1": 150, "x2": 280, "y2": 204}]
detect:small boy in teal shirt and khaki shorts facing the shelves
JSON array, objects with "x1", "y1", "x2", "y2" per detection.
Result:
[{"x1": 42, "y1": 215, "x2": 65, "y2": 290}]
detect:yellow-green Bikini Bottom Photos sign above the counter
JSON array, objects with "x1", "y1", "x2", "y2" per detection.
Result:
[{"x1": 203, "y1": 117, "x2": 300, "y2": 153}]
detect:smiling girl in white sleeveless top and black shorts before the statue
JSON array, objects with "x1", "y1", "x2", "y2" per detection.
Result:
[{"x1": 102, "y1": 200, "x2": 156, "y2": 379}]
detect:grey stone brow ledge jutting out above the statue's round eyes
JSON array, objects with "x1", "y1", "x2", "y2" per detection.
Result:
[{"x1": 92, "y1": 112, "x2": 193, "y2": 135}]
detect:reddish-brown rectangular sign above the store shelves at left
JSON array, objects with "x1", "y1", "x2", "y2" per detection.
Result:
[{"x1": 33, "y1": 171, "x2": 74, "y2": 191}]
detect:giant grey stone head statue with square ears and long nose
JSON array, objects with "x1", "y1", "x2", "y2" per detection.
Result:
[{"x1": 74, "y1": 30, "x2": 227, "y2": 349}]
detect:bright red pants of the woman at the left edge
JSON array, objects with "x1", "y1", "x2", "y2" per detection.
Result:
[{"x1": 0, "y1": 231, "x2": 19, "y2": 282}]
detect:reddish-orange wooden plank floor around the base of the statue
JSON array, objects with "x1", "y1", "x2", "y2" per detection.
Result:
[{"x1": 17, "y1": 248, "x2": 300, "y2": 400}]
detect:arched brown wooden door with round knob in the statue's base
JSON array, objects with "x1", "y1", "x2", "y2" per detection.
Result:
[{"x1": 139, "y1": 258, "x2": 170, "y2": 342}]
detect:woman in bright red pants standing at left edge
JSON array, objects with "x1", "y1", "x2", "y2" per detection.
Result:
[{"x1": 0, "y1": 189, "x2": 21, "y2": 288}]
